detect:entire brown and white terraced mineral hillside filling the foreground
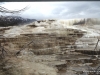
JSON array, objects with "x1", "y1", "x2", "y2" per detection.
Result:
[{"x1": 0, "y1": 18, "x2": 100, "y2": 75}]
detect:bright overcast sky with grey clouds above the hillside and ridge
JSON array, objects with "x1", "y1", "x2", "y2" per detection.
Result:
[{"x1": 2, "y1": 1, "x2": 100, "y2": 19}]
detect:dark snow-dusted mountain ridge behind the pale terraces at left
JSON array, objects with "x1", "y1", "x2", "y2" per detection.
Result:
[{"x1": 0, "y1": 15, "x2": 36, "y2": 27}]
